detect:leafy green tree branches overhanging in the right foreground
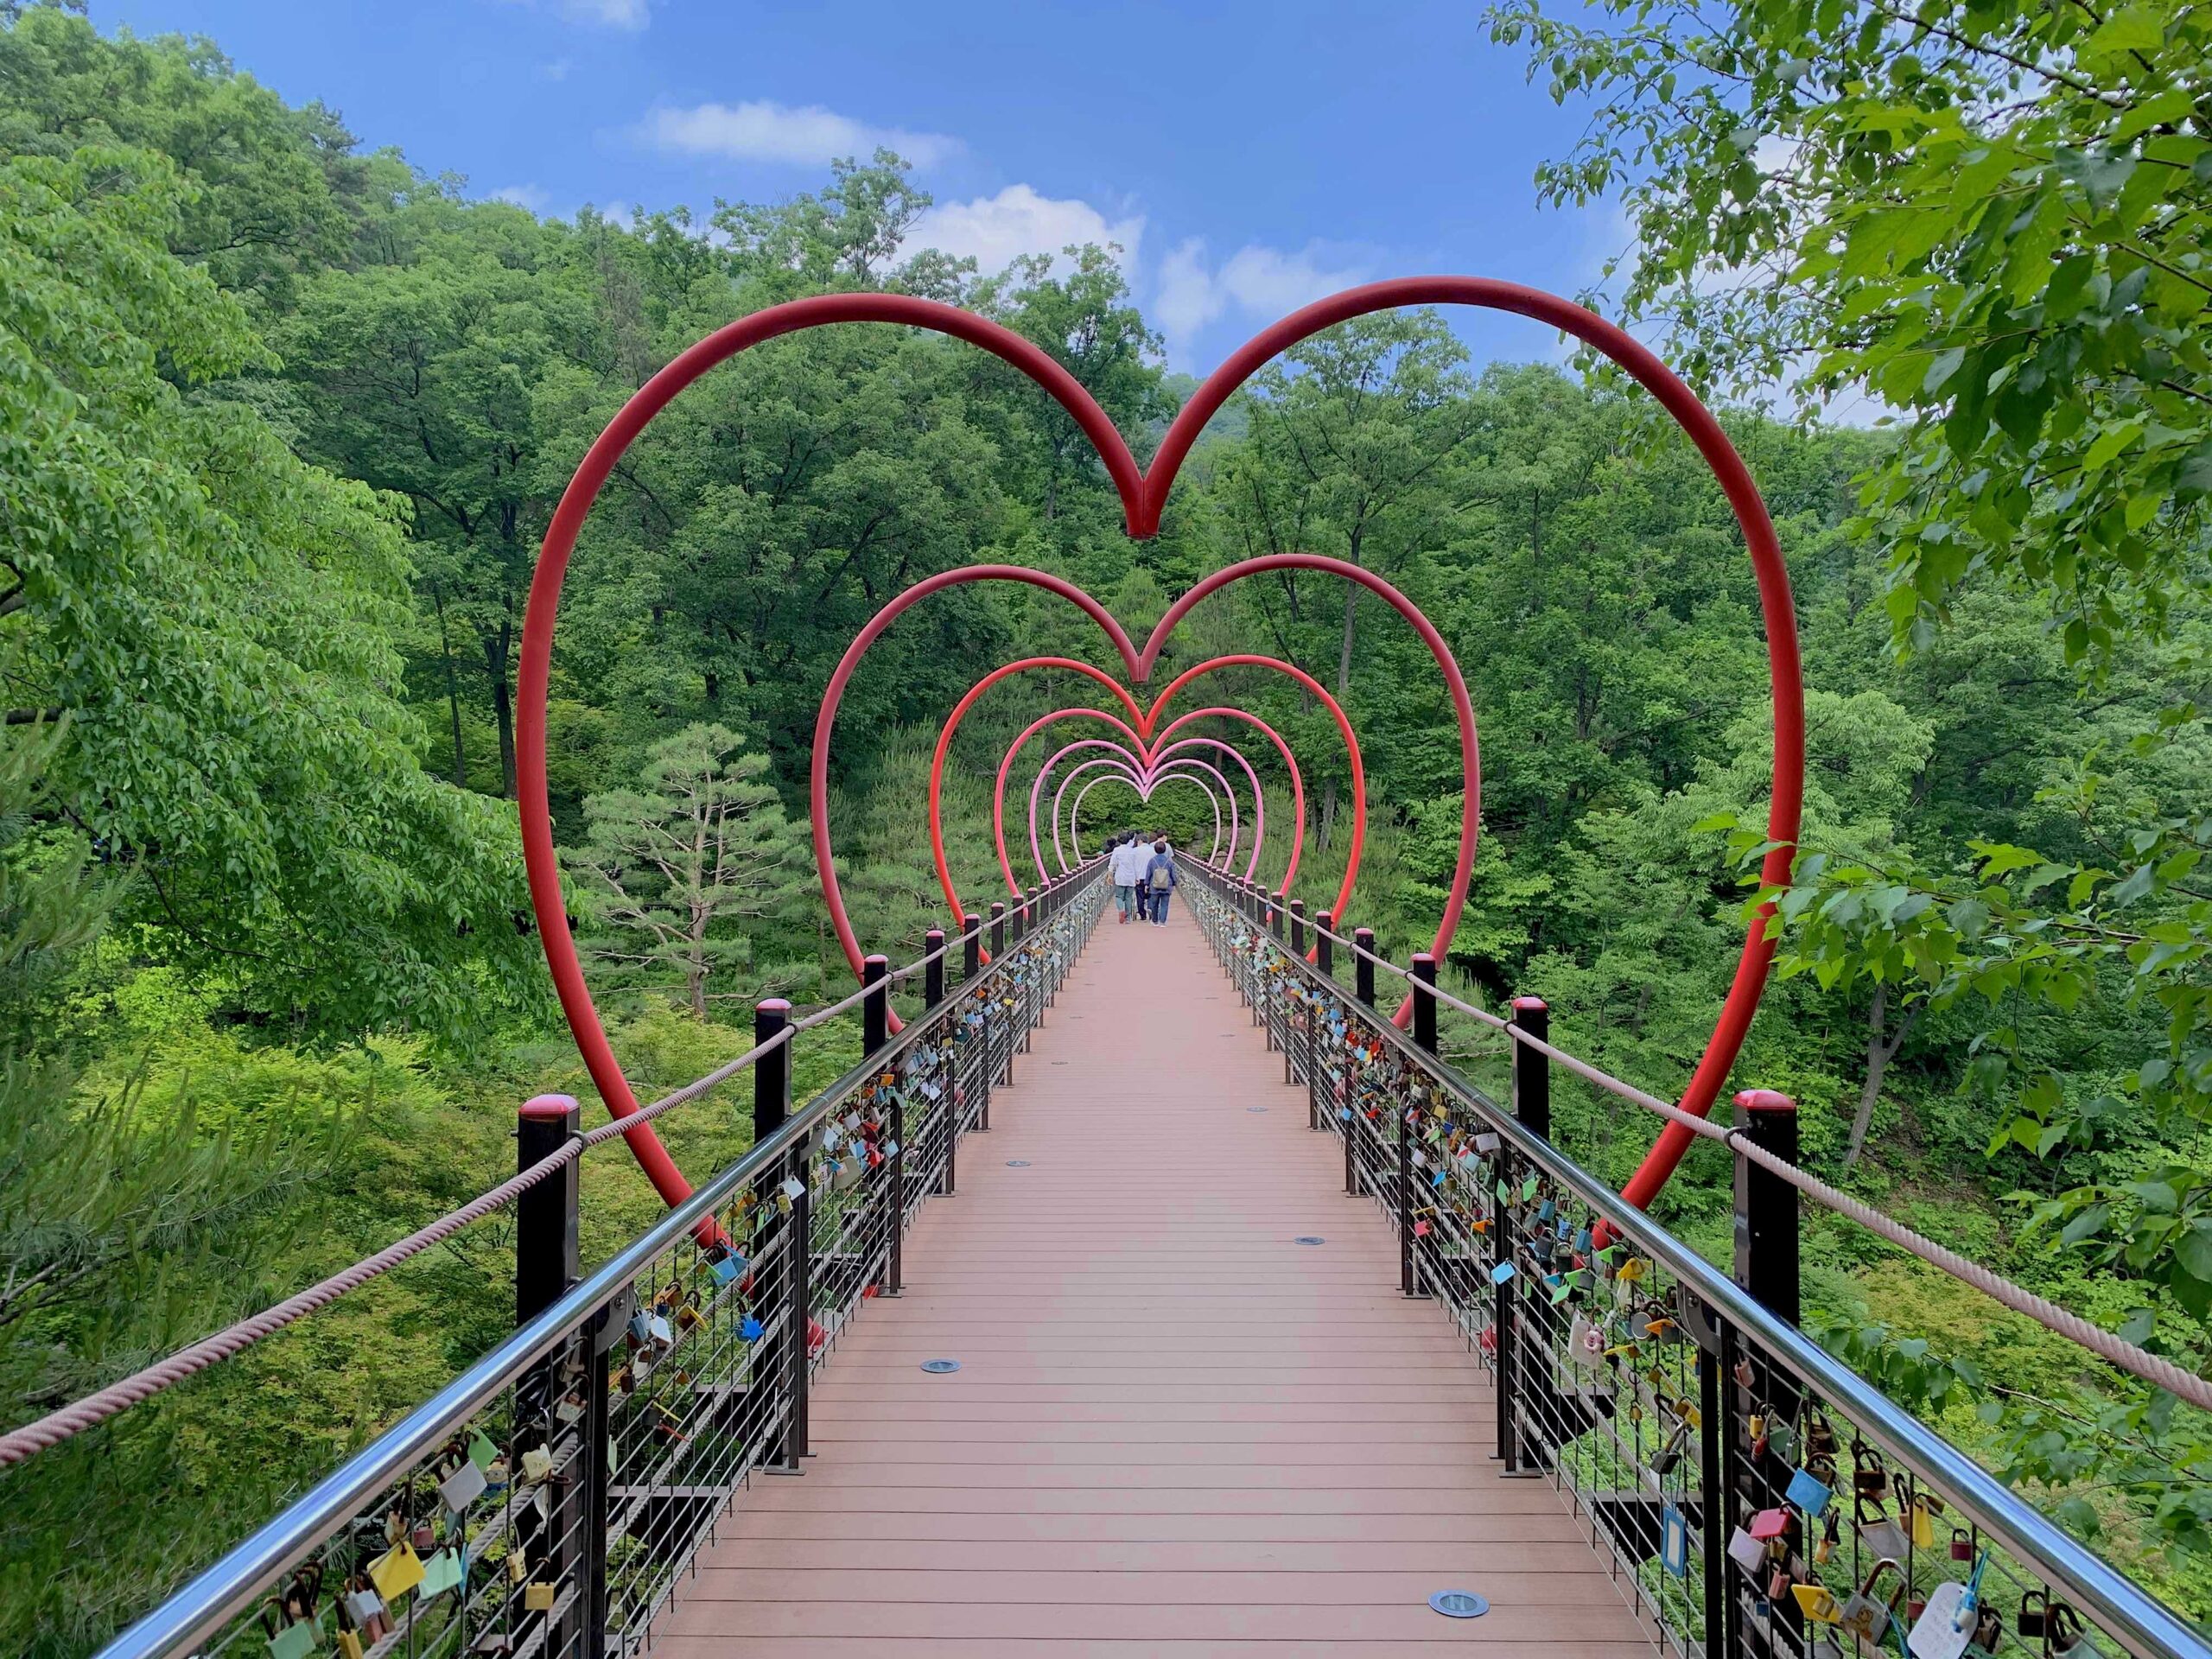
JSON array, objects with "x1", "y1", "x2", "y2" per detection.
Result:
[{"x1": 1491, "y1": 0, "x2": 2212, "y2": 1548}]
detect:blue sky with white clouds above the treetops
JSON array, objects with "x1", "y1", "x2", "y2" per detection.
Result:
[{"x1": 91, "y1": 0, "x2": 1626, "y2": 372}]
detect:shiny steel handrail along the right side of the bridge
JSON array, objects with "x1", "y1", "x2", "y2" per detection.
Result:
[{"x1": 1197, "y1": 872, "x2": 2212, "y2": 1659}]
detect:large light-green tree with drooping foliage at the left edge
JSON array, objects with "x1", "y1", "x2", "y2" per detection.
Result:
[{"x1": 0, "y1": 150, "x2": 526, "y2": 1031}]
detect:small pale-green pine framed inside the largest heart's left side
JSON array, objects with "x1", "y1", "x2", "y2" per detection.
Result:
[{"x1": 566, "y1": 726, "x2": 807, "y2": 1020}]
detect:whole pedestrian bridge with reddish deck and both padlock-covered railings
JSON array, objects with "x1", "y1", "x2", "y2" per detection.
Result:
[{"x1": 60, "y1": 862, "x2": 2212, "y2": 1659}]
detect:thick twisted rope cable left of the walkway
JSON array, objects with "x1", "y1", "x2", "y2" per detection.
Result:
[{"x1": 0, "y1": 907, "x2": 1079, "y2": 1469}]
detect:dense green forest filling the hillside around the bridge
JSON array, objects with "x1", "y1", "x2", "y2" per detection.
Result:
[{"x1": 0, "y1": 0, "x2": 2212, "y2": 1655}]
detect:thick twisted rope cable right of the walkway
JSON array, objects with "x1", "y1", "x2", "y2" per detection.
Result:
[{"x1": 1269, "y1": 898, "x2": 2212, "y2": 1411}]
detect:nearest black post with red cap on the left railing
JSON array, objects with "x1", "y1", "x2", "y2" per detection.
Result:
[{"x1": 509, "y1": 1095, "x2": 588, "y2": 1652}]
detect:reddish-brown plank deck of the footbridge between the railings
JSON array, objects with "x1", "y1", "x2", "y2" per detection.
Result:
[{"x1": 657, "y1": 900, "x2": 1652, "y2": 1659}]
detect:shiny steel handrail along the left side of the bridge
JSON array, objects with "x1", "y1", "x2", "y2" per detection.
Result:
[{"x1": 99, "y1": 865, "x2": 1102, "y2": 1659}]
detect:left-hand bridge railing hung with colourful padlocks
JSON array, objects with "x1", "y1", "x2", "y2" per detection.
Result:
[{"x1": 106, "y1": 865, "x2": 1103, "y2": 1659}]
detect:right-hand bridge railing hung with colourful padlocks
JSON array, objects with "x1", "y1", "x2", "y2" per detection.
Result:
[{"x1": 1184, "y1": 865, "x2": 2212, "y2": 1659}]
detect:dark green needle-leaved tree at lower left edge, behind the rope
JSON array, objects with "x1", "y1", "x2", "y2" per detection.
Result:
[{"x1": 0, "y1": 726, "x2": 339, "y2": 1652}]
